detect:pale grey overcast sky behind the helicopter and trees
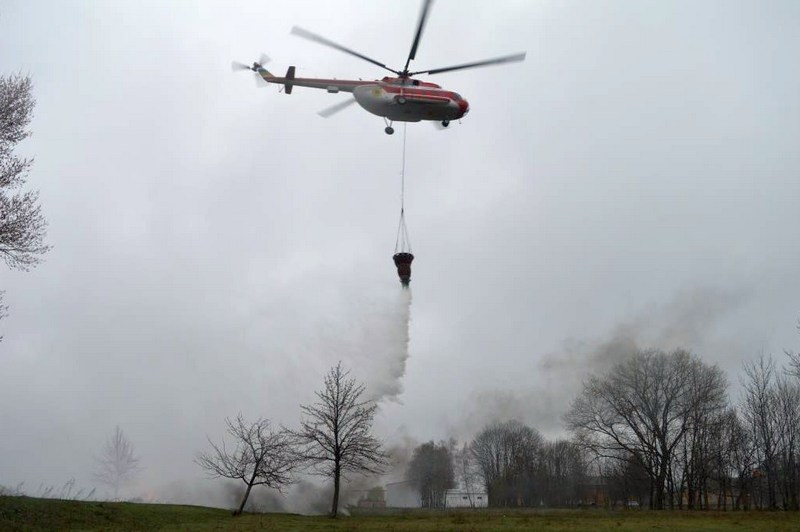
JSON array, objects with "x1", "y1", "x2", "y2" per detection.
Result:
[{"x1": 0, "y1": 0, "x2": 800, "y2": 508}]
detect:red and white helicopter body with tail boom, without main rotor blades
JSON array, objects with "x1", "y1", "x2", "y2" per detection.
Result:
[{"x1": 258, "y1": 68, "x2": 469, "y2": 122}]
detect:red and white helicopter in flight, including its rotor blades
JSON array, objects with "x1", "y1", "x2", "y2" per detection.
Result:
[{"x1": 232, "y1": 0, "x2": 525, "y2": 135}]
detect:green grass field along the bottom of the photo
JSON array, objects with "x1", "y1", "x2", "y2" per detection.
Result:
[{"x1": 0, "y1": 497, "x2": 800, "y2": 532}]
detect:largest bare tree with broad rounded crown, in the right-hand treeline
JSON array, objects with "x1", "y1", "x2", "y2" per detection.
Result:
[{"x1": 564, "y1": 349, "x2": 727, "y2": 509}]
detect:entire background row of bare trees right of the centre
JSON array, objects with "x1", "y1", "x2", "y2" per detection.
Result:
[{"x1": 407, "y1": 342, "x2": 800, "y2": 510}]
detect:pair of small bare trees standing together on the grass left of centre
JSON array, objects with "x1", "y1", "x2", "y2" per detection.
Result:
[{"x1": 196, "y1": 362, "x2": 387, "y2": 517}]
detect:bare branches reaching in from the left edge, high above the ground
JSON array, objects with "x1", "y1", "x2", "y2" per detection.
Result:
[{"x1": 0, "y1": 74, "x2": 49, "y2": 270}]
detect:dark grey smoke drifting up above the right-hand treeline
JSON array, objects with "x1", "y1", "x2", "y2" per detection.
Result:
[{"x1": 451, "y1": 287, "x2": 747, "y2": 440}]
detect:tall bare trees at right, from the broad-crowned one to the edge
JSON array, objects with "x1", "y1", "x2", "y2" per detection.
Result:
[{"x1": 565, "y1": 350, "x2": 800, "y2": 510}]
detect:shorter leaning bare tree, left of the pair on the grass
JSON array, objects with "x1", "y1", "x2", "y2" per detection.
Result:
[{"x1": 195, "y1": 414, "x2": 298, "y2": 515}]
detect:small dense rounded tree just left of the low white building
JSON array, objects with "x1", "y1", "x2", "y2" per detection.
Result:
[{"x1": 406, "y1": 441, "x2": 455, "y2": 508}]
